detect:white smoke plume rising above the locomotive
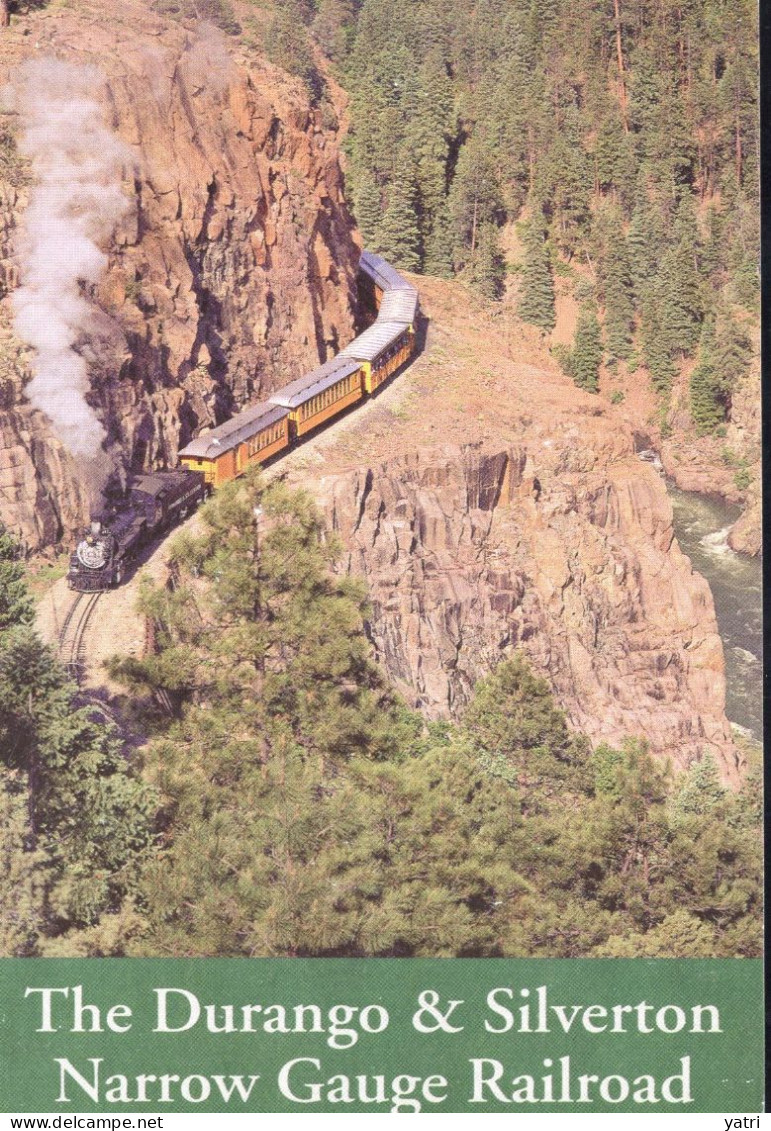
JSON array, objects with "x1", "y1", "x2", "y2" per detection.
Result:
[{"x1": 9, "y1": 59, "x2": 129, "y2": 461}]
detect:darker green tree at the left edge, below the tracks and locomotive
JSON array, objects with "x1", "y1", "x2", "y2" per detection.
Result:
[{"x1": 0, "y1": 534, "x2": 154, "y2": 955}]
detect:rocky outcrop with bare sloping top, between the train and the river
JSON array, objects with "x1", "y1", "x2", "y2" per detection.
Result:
[{"x1": 292, "y1": 280, "x2": 737, "y2": 780}]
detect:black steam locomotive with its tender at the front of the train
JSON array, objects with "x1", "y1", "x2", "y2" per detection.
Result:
[{"x1": 67, "y1": 469, "x2": 207, "y2": 593}]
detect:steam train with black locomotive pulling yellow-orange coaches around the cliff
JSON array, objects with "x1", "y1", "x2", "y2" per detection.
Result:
[{"x1": 67, "y1": 251, "x2": 418, "y2": 593}]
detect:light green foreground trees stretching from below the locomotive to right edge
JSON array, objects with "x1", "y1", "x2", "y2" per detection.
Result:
[{"x1": 97, "y1": 475, "x2": 760, "y2": 957}]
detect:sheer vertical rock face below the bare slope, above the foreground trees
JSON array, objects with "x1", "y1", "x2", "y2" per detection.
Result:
[{"x1": 321, "y1": 444, "x2": 735, "y2": 777}]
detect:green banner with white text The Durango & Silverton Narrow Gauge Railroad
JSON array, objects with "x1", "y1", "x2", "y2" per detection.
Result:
[{"x1": 0, "y1": 959, "x2": 763, "y2": 1114}]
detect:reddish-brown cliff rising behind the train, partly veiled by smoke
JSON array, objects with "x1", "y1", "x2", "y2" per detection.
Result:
[{"x1": 0, "y1": 0, "x2": 357, "y2": 549}]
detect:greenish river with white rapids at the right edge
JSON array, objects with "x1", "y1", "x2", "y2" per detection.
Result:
[{"x1": 668, "y1": 484, "x2": 763, "y2": 742}]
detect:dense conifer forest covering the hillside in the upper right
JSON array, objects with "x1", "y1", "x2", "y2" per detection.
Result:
[{"x1": 326, "y1": 0, "x2": 759, "y2": 420}]
